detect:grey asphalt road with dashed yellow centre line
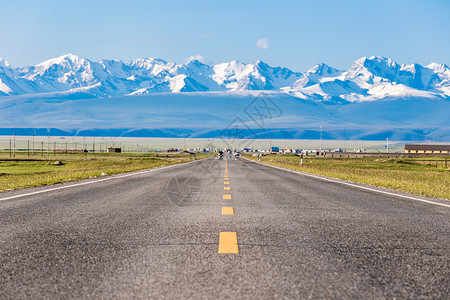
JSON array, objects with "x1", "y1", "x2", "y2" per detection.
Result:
[{"x1": 0, "y1": 158, "x2": 450, "y2": 299}]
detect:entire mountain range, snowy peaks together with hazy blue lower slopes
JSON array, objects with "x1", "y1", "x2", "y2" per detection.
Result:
[{"x1": 0, "y1": 54, "x2": 450, "y2": 142}]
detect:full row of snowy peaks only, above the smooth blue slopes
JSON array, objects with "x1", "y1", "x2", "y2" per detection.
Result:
[{"x1": 0, "y1": 54, "x2": 450, "y2": 103}]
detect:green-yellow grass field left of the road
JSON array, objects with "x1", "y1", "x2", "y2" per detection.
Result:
[{"x1": 0, "y1": 153, "x2": 209, "y2": 192}]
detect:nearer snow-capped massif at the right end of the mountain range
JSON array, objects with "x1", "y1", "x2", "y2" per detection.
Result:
[{"x1": 283, "y1": 56, "x2": 450, "y2": 102}]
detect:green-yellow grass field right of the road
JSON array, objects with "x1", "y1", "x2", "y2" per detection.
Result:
[{"x1": 245, "y1": 155, "x2": 450, "y2": 199}]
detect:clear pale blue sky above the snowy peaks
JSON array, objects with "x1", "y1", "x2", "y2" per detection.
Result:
[{"x1": 0, "y1": 0, "x2": 450, "y2": 71}]
